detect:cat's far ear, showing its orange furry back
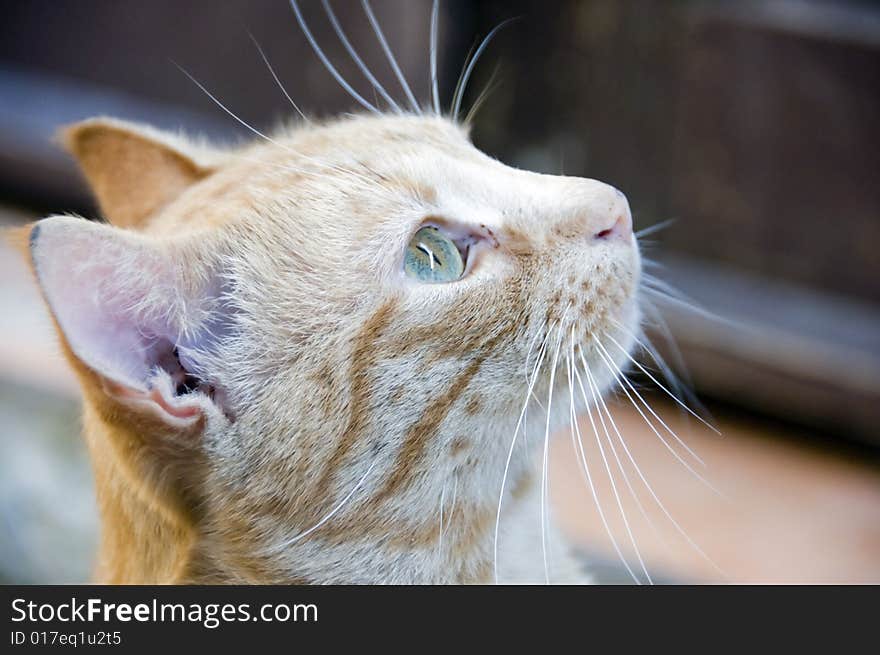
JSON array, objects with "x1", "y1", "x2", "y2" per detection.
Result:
[{"x1": 59, "y1": 118, "x2": 215, "y2": 228}]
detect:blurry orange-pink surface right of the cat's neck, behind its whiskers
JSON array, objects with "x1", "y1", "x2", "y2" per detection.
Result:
[{"x1": 552, "y1": 396, "x2": 880, "y2": 583}]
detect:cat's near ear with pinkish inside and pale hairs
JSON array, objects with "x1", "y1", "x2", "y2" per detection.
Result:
[{"x1": 30, "y1": 216, "x2": 226, "y2": 429}]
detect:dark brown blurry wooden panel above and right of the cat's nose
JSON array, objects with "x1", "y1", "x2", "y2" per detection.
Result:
[{"x1": 472, "y1": 0, "x2": 880, "y2": 302}]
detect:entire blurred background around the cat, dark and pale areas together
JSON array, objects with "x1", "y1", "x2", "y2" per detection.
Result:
[{"x1": 0, "y1": 0, "x2": 880, "y2": 583}]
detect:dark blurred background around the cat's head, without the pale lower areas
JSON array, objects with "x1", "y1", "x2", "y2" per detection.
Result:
[{"x1": 0, "y1": 0, "x2": 880, "y2": 584}]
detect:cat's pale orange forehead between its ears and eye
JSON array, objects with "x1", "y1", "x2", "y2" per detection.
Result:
[{"x1": 149, "y1": 115, "x2": 470, "y2": 234}]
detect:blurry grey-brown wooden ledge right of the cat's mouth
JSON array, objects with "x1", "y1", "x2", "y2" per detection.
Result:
[{"x1": 647, "y1": 257, "x2": 880, "y2": 448}]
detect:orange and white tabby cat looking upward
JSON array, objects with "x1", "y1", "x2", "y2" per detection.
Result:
[{"x1": 12, "y1": 3, "x2": 641, "y2": 584}]
